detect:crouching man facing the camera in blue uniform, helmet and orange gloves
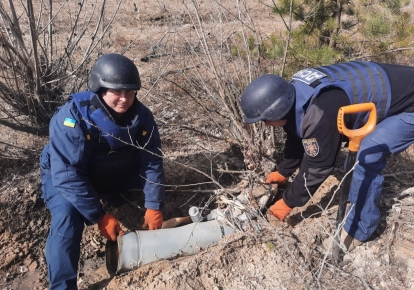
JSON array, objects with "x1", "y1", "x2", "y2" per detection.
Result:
[{"x1": 40, "y1": 54, "x2": 165, "y2": 289}]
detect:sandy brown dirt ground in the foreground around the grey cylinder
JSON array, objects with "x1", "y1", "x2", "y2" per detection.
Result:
[{"x1": 0, "y1": 127, "x2": 414, "y2": 289}]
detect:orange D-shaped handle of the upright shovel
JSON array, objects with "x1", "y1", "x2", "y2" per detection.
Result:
[{"x1": 337, "y1": 103, "x2": 377, "y2": 152}]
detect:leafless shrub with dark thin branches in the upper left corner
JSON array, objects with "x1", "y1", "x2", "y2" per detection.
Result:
[{"x1": 0, "y1": 0, "x2": 121, "y2": 132}]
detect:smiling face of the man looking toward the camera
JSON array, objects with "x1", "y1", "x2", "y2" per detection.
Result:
[{"x1": 102, "y1": 89, "x2": 136, "y2": 117}]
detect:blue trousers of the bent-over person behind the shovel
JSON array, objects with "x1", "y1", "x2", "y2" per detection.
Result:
[{"x1": 344, "y1": 113, "x2": 414, "y2": 242}]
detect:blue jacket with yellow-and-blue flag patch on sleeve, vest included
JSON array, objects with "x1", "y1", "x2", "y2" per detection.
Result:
[{"x1": 40, "y1": 91, "x2": 165, "y2": 224}]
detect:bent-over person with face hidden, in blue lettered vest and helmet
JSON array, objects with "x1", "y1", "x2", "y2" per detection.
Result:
[{"x1": 241, "y1": 61, "x2": 414, "y2": 250}]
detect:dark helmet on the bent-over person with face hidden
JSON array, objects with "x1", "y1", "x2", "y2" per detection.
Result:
[{"x1": 241, "y1": 74, "x2": 295, "y2": 124}]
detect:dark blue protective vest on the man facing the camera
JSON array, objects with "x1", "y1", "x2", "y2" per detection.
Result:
[{"x1": 70, "y1": 91, "x2": 145, "y2": 193}]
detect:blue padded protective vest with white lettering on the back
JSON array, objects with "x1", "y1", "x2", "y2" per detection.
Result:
[{"x1": 290, "y1": 61, "x2": 391, "y2": 138}]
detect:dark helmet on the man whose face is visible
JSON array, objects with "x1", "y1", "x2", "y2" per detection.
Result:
[{"x1": 88, "y1": 53, "x2": 141, "y2": 93}]
